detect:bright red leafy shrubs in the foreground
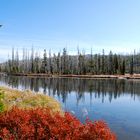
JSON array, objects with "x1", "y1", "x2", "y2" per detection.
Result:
[{"x1": 0, "y1": 108, "x2": 116, "y2": 140}]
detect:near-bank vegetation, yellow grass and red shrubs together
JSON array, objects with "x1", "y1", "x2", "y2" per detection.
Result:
[{"x1": 0, "y1": 87, "x2": 116, "y2": 140}]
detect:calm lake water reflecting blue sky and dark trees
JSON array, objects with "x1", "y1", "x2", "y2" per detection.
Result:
[{"x1": 0, "y1": 76, "x2": 140, "y2": 140}]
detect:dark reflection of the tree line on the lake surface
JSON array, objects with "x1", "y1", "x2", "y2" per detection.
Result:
[{"x1": 0, "y1": 76, "x2": 140, "y2": 103}]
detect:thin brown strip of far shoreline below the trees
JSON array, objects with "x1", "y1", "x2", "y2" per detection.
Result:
[{"x1": 0, "y1": 73, "x2": 140, "y2": 79}]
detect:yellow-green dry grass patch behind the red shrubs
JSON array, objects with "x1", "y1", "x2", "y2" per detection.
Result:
[{"x1": 0, "y1": 87, "x2": 61, "y2": 112}]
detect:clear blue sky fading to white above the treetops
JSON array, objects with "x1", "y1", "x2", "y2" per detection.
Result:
[{"x1": 0, "y1": 0, "x2": 140, "y2": 61}]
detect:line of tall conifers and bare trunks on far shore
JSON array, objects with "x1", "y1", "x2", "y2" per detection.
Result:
[{"x1": 0, "y1": 48, "x2": 140, "y2": 75}]
